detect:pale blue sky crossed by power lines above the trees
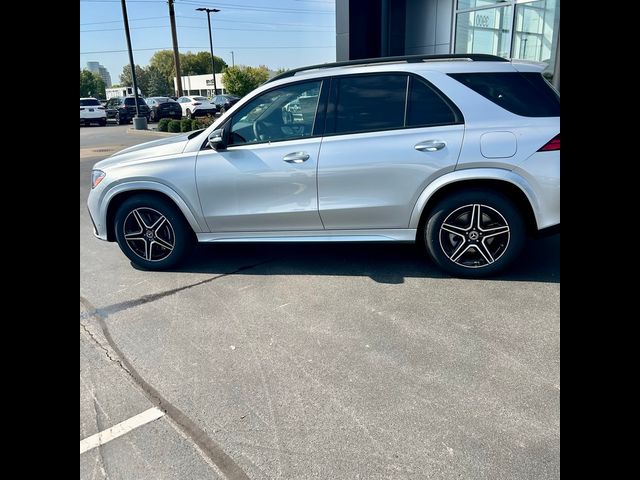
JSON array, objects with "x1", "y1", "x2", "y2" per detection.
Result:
[{"x1": 80, "y1": 0, "x2": 336, "y2": 84}]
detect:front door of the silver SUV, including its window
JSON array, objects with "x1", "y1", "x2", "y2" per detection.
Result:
[{"x1": 196, "y1": 81, "x2": 322, "y2": 232}]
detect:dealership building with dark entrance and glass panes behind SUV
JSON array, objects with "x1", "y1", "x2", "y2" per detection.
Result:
[{"x1": 336, "y1": 0, "x2": 560, "y2": 90}]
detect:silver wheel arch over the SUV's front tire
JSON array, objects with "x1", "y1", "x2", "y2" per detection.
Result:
[{"x1": 104, "y1": 182, "x2": 203, "y2": 242}]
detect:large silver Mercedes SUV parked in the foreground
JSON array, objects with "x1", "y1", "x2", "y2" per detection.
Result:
[{"x1": 88, "y1": 54, "x2": 560, "y2": 277}]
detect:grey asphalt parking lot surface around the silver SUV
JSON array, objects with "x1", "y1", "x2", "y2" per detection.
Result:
[{"x1": 80, "y1": 125, "x2": 560, "y2": 480}]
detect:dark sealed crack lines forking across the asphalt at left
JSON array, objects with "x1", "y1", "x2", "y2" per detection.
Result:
[{"x1": 80, "y1": 259, "x2": 273, "y2": 480}]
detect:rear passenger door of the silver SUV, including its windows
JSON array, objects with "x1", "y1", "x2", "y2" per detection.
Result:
[{"x1": 318, "y1": 72, "x2": 464, "y2": 229}]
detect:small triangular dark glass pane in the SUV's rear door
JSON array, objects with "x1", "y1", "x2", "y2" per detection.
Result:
[{"x1": 407, "y1": 78, "x2": 462, "y2": 127}]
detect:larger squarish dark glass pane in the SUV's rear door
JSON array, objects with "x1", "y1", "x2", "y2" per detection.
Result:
[{"x1": 335, "y1": 75, "x2": 407, "y2": 133}]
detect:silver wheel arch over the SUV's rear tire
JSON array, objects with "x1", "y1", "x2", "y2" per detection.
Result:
[{"x1": 409, "y1": 169, "x2": 538, "y2": 240}]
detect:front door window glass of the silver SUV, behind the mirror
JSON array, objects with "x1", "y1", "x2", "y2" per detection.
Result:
[{"x1": 229, "y1": 80, "x2": 322, "y2": 145}]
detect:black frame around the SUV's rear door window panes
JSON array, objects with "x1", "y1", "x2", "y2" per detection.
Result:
[{"x1": 323, "y1": 70, "x2": 465, "y2": 137}]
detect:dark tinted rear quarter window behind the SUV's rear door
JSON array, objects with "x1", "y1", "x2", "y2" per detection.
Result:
[{"x1": 449, "y1": 72, "x2": 560, "y2": 117}]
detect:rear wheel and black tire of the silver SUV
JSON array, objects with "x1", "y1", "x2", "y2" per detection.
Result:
[{"x1": 423, "y1": 189, "x2": 526, "y2": 278}]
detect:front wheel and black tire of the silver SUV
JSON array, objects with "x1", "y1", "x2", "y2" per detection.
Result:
[{"x1": 115, "y1": 194, "x2": 194, "y2": 270}]
